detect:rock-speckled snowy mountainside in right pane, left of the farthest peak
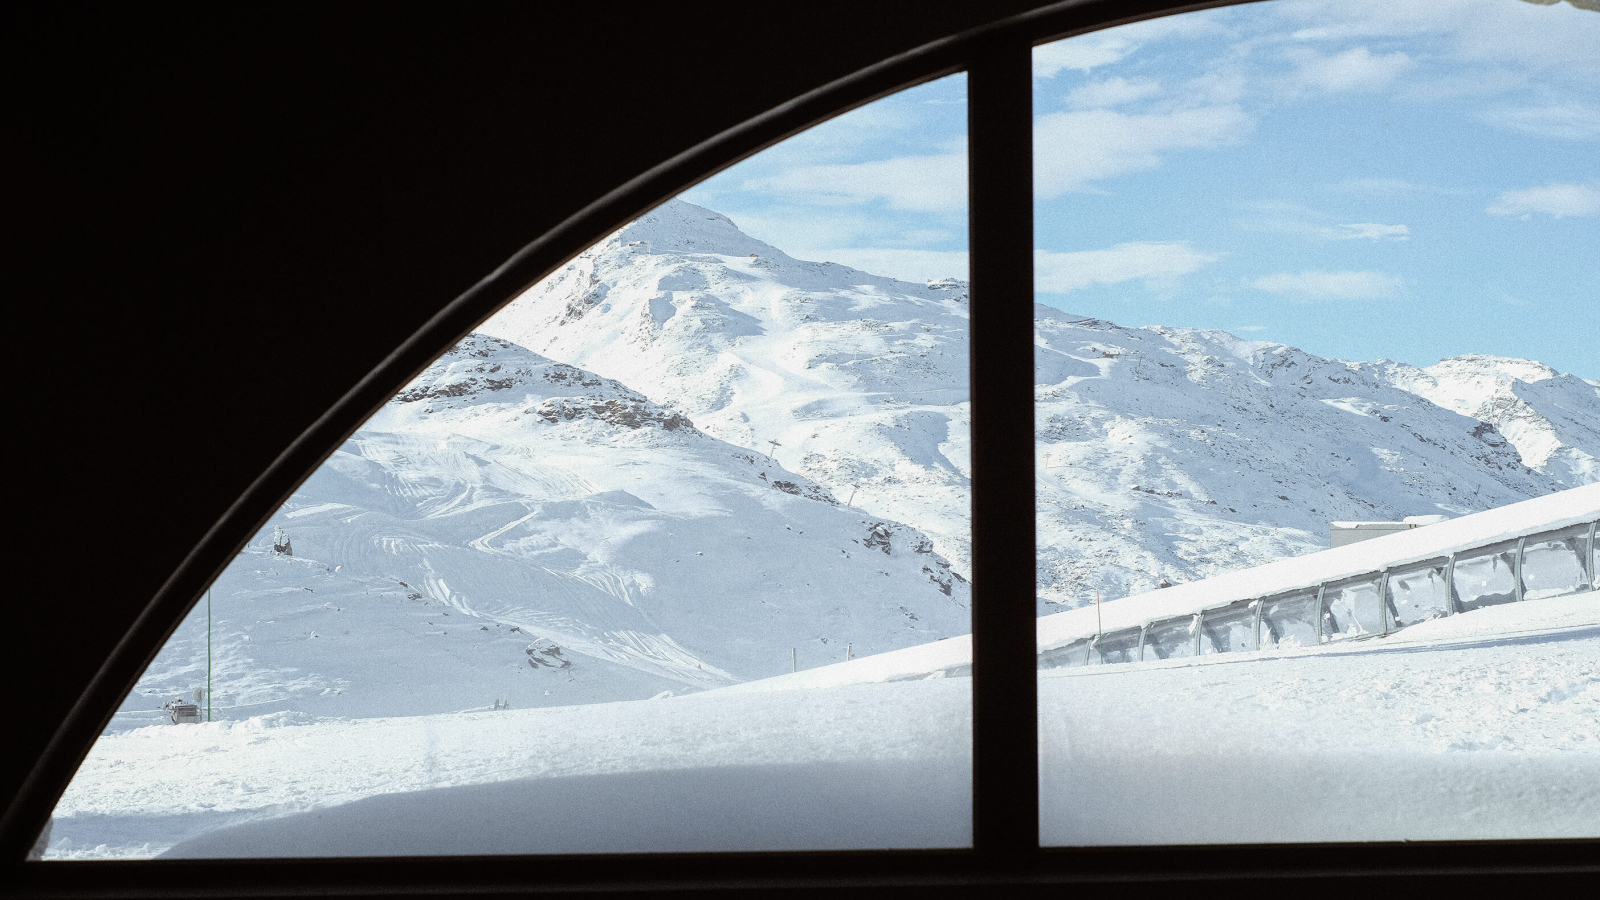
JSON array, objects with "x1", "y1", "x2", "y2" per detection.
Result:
[{"x1": 1035, "y1": 306, "x2": 1558, "y2": 605}]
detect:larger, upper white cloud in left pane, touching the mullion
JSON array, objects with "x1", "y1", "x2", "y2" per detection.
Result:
[{"x1": 744, "y1": 152, "x2": 966, "y2": 211}]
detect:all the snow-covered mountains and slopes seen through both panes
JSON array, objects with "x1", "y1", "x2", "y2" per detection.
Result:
[{"x1": 118, "y1": 202, "x2": 1600, "y2": 725}]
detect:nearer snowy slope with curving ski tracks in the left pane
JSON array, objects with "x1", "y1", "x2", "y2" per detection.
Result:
[{"x1": 125, "y1": 335, "x2": 970, "y2": 724}]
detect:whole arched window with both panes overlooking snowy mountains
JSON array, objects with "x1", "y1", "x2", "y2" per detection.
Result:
[{"x1": 12, "y1": 0, "x2": 1600, "y2": 881}]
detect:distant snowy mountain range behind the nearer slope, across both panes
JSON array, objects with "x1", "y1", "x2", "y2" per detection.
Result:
[{"x1": 485, "y1": 202, "x2": 1600, "y2": 605}]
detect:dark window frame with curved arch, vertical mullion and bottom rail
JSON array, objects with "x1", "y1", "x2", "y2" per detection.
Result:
[{"x1": 9, "y1": 0, "x2": 1600, "y2": 895}]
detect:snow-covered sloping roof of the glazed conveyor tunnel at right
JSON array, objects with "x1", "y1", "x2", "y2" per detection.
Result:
[{"x1": 1038, "y1": 484, "x2": 1600, "y2": 652}]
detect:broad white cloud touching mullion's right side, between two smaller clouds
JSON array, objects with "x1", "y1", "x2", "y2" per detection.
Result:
[{"x1": 1034, "y1": 106, "x2": 1254, "y2": 197}]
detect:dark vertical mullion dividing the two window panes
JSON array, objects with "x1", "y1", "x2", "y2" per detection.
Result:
[{"x1": 966, "y1": 38, "x2": 1038, "y2": 862}]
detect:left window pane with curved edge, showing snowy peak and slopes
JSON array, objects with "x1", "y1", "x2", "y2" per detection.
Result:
[{"x1": 46, "y1": 75, "x2": 971, "y2": 858}]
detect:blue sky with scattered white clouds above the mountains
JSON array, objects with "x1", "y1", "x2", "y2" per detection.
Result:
[{"x1": 685, "y1": 0, "x2": 1600, "y2": 373}]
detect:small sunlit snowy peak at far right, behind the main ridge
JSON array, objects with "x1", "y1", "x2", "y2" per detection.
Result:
[{"x1": 1371, "y1": 354, "x2": 1600, "y2": 487}]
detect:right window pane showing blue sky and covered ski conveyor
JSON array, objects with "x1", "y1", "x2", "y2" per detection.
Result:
[{"x1": 1034, "y1": 0, "x2": 1600, "y2": 846}]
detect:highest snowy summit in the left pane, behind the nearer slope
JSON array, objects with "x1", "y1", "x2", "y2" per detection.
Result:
[{"x1": 483, "y1": 200, "x2": 968, "y2": 570}]
